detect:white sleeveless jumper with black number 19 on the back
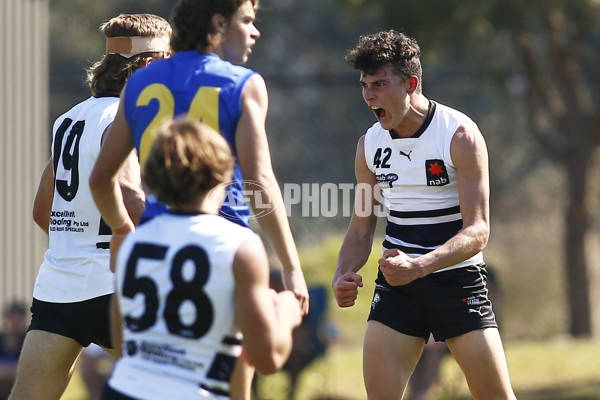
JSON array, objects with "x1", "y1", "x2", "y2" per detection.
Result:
[{"x1": 33, "y1": 96, "x2": 119, "y2": 303}]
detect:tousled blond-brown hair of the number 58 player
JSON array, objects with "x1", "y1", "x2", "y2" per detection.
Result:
[{"x1": 142, "y1": 118, "x2": 235, "y2": 209}]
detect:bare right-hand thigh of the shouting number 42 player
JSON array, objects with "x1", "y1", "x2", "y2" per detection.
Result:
[{"x1": 446, "y1": 328, "x2": 516, "y2": 400}]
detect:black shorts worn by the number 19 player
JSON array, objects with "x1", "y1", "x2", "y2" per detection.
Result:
[{"x1": 28, "y1": 294, "x2": 112, "y2": 349}]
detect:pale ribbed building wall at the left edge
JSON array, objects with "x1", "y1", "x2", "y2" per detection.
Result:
[{"x1": 0, "y1": 0, "x2": 50, "y2": 320}]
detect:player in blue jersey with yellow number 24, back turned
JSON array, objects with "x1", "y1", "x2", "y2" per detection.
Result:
[{"x1": 90, "y1": 0, "x2": 308, "y2": 398}]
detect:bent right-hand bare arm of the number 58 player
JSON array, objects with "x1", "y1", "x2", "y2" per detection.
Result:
[{"x1": 233, "y1": 236, "x2": 302, "y2": 374}]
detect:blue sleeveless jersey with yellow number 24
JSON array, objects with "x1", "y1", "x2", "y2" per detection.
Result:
[{"x1": 123, "y1": 50, "x2": 254, "y2": 226}]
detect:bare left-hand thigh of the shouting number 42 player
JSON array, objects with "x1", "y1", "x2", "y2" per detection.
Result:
[{"x1": 363, "y1": 321, "x2": 425, "y2": 400}]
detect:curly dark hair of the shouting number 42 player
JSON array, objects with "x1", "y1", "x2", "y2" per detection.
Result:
[{"x1": 345, "y1": 29, "x2": 423, "y2": 92}]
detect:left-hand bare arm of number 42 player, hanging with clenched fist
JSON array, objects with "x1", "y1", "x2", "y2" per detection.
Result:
[{"x1": 332, "y1": 136, "x2": 379, "y2": 307}]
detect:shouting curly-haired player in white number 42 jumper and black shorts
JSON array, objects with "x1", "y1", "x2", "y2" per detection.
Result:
[{"x1": 332, "y1": 30, "x2": 515, "y2": 400}]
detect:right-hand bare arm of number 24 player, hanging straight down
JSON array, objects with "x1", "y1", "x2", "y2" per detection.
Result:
[{"x1": 235, "y1": 74, "x2": 308, "y2": 314}]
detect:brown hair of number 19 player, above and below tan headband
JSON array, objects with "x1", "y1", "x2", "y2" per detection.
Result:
[{"x1": 86, "y1": 14, "x2": 171, "y2": 96}]
